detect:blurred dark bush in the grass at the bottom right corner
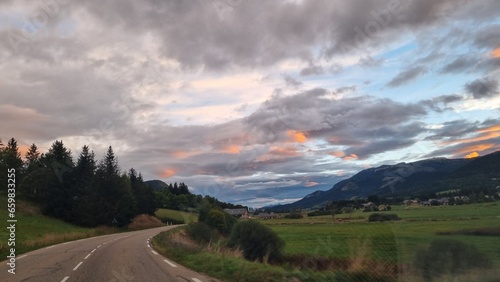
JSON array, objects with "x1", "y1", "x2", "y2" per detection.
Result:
[{"x1": 414, "y1": 239, "x2": 492, "y2": 281}]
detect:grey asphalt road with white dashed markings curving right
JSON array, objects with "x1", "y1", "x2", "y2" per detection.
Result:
[{"x1": 0, "y1": 226, "x2": 217, "y2": 282}]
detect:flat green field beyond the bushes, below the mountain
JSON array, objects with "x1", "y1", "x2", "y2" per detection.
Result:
[{"x1": 261, "y1": 203, "x2": 500, "y2": 262}]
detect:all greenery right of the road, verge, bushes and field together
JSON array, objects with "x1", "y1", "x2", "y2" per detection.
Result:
[{"x1": 154, "y1": 202, "x2": 500, "y2": 281}]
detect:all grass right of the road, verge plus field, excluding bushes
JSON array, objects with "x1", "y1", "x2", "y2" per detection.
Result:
[{"x1": 154, "y1": 203, "x2": 500, "y2": 281}]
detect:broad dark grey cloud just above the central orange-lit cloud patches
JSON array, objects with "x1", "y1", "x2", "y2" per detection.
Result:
[{"x1": 244, "y1": 89, "x2": 426, "y2": 159}]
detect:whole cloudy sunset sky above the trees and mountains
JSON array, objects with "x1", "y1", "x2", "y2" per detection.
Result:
[{"x1": 0, "y1": 0, "x2": 500, "y2": 207}]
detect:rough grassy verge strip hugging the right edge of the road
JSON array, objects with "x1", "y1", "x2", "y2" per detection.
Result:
[{"x1": 152, "y1": 227, "x2": 392, "y2": 282}]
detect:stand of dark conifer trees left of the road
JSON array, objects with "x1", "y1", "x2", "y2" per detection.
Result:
[{"x1": 0, "y1": 138, "x2": 156, "y2": 227}]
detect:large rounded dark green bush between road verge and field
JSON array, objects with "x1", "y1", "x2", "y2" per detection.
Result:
[{"x1": 228, "y1": 220, "x2": 285, "y2": 262}]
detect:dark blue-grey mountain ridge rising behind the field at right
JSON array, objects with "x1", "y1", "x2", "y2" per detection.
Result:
[{"x1": 266, "y1": 151, "x2": 500, "y2": 211}]
